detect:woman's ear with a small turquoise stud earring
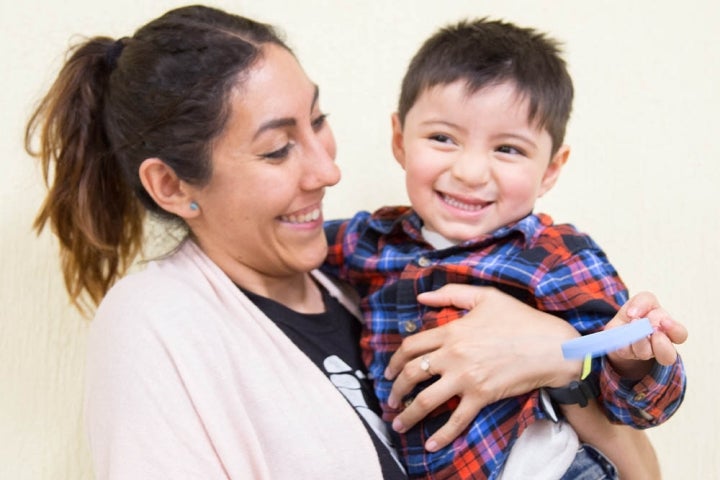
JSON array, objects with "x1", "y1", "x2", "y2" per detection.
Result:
[{"x1": 138, "y1": 158, "x2": 200, "y2": 219}]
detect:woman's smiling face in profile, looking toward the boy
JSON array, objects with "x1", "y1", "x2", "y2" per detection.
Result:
[{"x1": 188, "y1": 45, "x2": 340, "y2": 286}]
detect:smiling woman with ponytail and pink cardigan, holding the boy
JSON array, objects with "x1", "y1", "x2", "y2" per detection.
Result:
[{"x1": 27, "y1": 6, "x2": 676, "y2": 479}]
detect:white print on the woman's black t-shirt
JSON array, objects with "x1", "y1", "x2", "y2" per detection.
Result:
[{"x1": 323, "y1": 355, "x2": 405, "y2": 472}]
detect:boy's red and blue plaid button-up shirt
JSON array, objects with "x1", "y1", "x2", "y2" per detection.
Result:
[{"x1": 323, "y1": 207, "x2": 685, "y2": 479}]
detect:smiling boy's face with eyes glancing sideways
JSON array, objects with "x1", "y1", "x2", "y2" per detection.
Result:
[{"x1": 393, "y1": 80, "x2": 570, "y2": 242}]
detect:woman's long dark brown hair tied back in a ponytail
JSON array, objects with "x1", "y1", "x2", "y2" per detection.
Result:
[{"x1": 25, "y1": 6, "x2": 289, "y2": 310}]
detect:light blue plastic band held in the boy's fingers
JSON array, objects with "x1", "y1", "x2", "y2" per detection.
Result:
[{"x1": 562, "y1": 318, "x2": 653, "y2": 360}]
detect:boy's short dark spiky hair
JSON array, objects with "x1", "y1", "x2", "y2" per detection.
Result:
[{"x1": 398, "y1": 18, "x2": 573, "y2": 153}]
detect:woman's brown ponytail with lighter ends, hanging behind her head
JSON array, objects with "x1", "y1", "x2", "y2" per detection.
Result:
[{"x1": 25, "y1": 37, "x2": 144, "y2": 311}]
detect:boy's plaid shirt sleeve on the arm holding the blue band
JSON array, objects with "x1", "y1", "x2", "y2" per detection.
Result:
[{"x1": 535, "y1": 244, "x2": 686, "y2": 428}]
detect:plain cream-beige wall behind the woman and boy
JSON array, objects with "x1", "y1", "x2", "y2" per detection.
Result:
[{"x1": 0, "y1": 0, "x2": 720, "y2": 479}]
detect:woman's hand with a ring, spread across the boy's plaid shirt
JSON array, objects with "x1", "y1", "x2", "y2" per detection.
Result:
[{"x1": 385, "y1": 285, "x2": 581, "y2": 451}]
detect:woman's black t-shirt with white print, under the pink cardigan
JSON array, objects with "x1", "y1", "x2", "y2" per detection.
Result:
[{"x1": 242, "y1": 287, "x2": 407, "y2": 479}]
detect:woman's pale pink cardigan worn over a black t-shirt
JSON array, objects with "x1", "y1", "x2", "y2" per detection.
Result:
[{"x1": 85, "y1": 241, "x2": 382, "y2": 480}]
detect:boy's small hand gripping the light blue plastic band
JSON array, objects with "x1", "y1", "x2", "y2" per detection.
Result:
[{"x1": 605, "y1": 292, "x2": 688, "y2": 380}]
